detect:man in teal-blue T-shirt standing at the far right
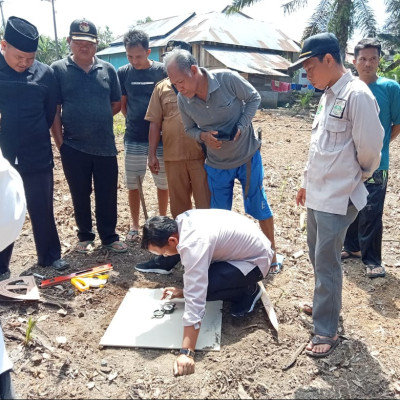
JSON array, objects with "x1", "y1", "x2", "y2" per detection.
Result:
[{"x1": 342, "y1": 38, "x2": 400, "y2": 278}]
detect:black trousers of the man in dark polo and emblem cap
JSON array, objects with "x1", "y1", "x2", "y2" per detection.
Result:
[{"x1": 60, "y1": 144, "x2": 119, "y2": 245}]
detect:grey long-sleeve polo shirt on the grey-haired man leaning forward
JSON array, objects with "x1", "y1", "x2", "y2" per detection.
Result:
[{"x1": 178, "y1": 68, "x2": 261, "y2": 169}]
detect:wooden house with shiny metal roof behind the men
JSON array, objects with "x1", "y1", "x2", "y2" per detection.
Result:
[{"x1": 97, "y1": 11, "x2": 300, "y2": 107}]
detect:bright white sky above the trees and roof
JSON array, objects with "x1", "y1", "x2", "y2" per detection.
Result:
[{"x1": 0, "y1": 0, "x2": 386, "y2": 41}]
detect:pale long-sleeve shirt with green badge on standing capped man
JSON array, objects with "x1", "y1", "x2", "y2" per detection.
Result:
[{"x1": 302, "y1": 71, "x2": 383, "y2": 215}]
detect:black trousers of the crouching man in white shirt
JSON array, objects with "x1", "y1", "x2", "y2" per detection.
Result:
[{"x1": 207, "y1": 261, "x2": 263, "y2": 302}]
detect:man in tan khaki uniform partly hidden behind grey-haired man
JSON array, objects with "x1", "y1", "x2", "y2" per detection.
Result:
[{"x1": 136, "y1": 41, "x2": 210, "y2": 274}]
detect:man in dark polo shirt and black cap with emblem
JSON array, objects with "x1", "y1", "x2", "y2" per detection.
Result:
[{"x1": 51, "y1": 18, "x2": 127, "y2": 254}]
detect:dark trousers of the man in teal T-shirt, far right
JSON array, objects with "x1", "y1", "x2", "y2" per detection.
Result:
[{"x1": 344, "y1": 170, "x2": 388, "y2": 266}]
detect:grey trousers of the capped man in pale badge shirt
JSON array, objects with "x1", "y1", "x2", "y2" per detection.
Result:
[{"x1": 307, "y1": 205, "x2": 357, "y2": 337}]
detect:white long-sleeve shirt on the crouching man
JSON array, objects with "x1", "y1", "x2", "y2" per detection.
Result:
[{"x1": 176, "y1": 209, "x2": 273, "y2": 326}]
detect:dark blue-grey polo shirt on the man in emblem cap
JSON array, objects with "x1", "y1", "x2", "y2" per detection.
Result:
[{"x1": 51, "y1": 57, "x2": 121, "y2": 156}]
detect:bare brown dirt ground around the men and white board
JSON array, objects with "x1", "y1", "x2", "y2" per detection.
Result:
[{"x1": 0, "y1": 109, "x2": 400, "y2": 399}]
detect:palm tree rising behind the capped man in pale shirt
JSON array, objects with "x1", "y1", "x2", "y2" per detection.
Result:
[{"x1": 226, "y1": 0, "x2": 378, "y2": 59}]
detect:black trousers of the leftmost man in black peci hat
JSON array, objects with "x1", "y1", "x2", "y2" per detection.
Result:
[{"x1": 0, "y1": 170, "x2": 61, "y2": 272}]
